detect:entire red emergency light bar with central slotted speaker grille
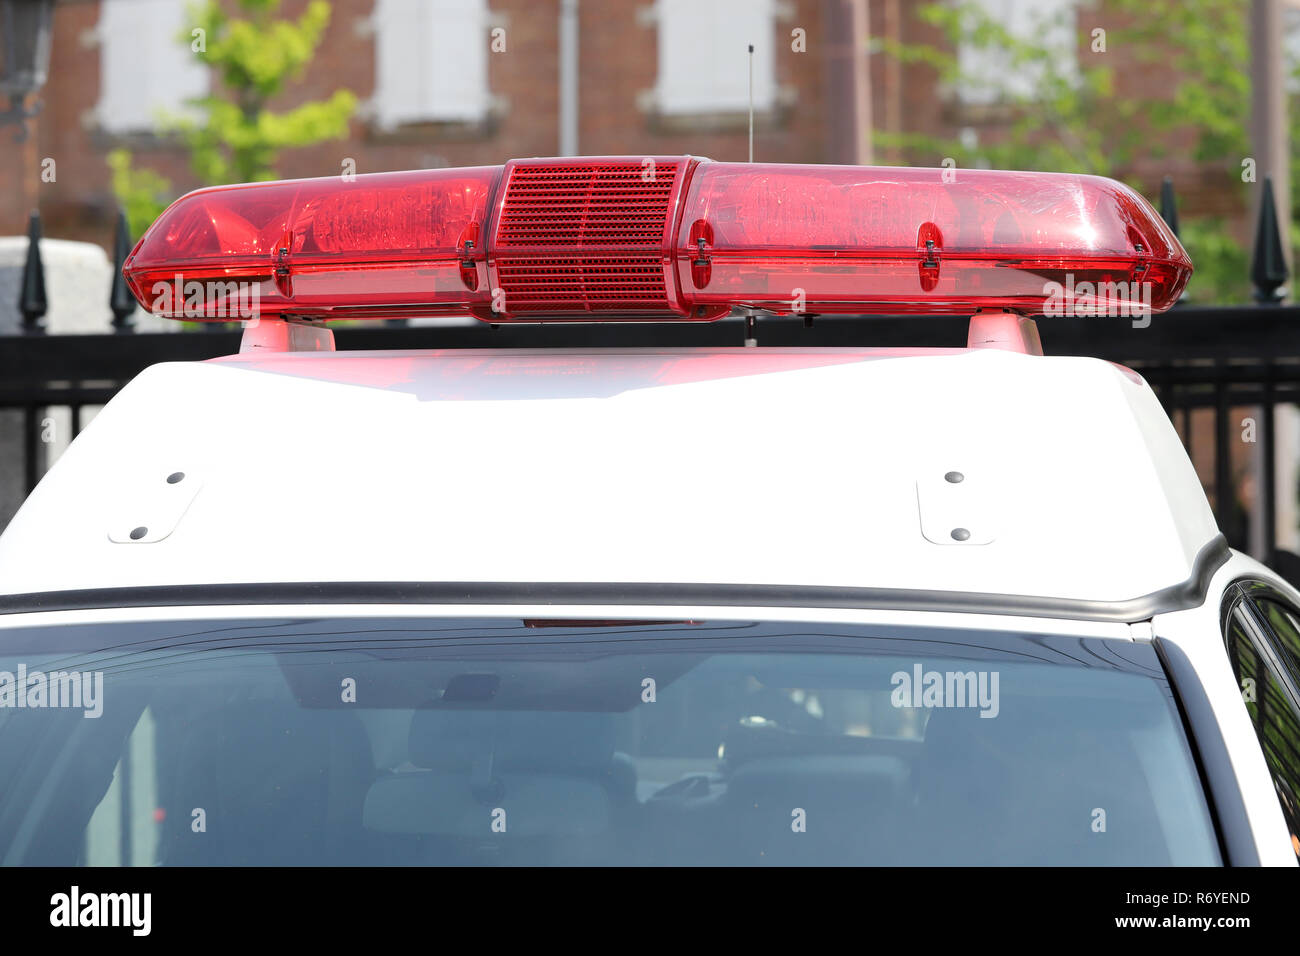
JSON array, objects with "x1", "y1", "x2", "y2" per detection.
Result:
[{"x1": 124, "y1": 156, "x2": 1192, "y2": 323}]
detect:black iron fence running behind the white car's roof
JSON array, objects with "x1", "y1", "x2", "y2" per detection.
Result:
[{"x1": 0, "y1": 306, "x2": 1300, "y2": 555}]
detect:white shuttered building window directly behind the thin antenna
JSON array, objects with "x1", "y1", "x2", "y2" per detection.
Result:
[{"x1": 655, "y1": 0, "x2": 776, "y2": 114}]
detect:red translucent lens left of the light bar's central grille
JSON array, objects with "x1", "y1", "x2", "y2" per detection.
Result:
[{"x1": 122, "y1": 166, "x2": 501, "y2": 320}]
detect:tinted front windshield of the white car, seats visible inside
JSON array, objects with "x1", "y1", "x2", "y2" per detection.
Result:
[{"x1": 0, "y1": 617, "x2": 1221, "y2": 866}]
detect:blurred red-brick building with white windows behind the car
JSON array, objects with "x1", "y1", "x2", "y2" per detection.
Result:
[{"x1": 0, "y1": 0, "x2": 1258, "y2": 256}]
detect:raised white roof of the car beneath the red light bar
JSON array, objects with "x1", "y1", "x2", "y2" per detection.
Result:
[{"x1": 0, "y1": 349, "x2": 1227, "y2": 619}]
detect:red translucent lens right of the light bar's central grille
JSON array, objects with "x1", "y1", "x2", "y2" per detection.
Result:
[{"x1": 677, "y1": 163, "x2": 1192, "y2": 315}]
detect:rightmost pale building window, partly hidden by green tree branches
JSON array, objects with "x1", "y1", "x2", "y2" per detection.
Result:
[{"x1": 956, "y1": 0, "x2": 1079, "y2": 105}]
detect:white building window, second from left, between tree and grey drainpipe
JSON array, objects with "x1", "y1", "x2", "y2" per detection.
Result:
[{"x1": 373, "y1": 0, "x2": 490, "y2": 129}]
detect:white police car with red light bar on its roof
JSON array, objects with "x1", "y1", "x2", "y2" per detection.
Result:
[{"x1": 0, "y1": 156, "x2": 1300, "y2": 866}]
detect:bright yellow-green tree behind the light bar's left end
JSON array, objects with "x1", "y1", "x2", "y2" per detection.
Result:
[{"x1": 108, "y1": 0, "x2": 356, "y2": 235}]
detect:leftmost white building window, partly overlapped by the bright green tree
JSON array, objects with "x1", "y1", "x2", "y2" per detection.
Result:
[{"x1": 96, "y1": 0, "x2": 208, "y2": 133}]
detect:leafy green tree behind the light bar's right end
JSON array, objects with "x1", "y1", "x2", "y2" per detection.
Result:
[{"x1": 875, "y1": 0, "x2": 1258, "y2": 300}]
